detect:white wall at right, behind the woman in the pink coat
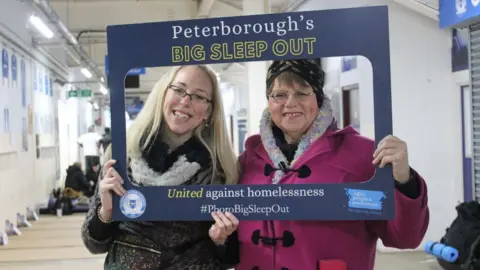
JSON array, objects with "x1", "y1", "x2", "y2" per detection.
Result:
[{"x1": 299, "y1": 0, "x2": 463, "y2": 253}]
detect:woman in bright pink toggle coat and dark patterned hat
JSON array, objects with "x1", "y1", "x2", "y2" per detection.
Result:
[{"x1": 218, "y1": 60, "x2": 429, "y2": 270}]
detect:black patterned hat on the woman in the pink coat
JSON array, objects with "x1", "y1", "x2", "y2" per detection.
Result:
[{"x1": 267, "y1": 59, "x2": 325, "y2": 107}]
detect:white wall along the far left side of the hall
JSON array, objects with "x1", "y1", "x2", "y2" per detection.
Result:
[{"x1": 0, "y1": 1, "x2": 89, "y2": 234}]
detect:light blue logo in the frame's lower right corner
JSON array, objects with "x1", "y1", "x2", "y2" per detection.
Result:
[{"x1": 345, "y1": 188, "x2": 386, "y2": 214}]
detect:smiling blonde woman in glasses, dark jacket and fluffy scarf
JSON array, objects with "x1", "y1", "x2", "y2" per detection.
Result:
[{"x1": 82, "y1": 66, "x2": 244, "y2": 270}]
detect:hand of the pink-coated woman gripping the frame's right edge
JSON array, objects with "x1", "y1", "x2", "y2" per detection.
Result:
[{"x1": 373, "y1": 135, "x2": 410, "y2": 184}]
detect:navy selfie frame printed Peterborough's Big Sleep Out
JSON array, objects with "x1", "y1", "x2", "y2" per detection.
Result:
[{"x1": 107, "y1": 6, "x2": 395, "y2": 221}]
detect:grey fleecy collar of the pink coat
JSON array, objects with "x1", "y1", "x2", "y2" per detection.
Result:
[{"x1": 260, "y1": 96, "x2": 334, "y2": 184}]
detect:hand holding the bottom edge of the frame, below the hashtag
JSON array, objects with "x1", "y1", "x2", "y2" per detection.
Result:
[{"x1": 208, "y1": 212, "x2": 238, "y2": 245}]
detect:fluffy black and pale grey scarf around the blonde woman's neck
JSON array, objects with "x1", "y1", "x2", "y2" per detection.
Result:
[{"x1": 130, "y1": 137, "x2": 211, "y2": 186}]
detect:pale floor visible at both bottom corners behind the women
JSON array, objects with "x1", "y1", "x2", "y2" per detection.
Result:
[{"x1": 0, "y1": 215, "x2": 441, "y2": 270}]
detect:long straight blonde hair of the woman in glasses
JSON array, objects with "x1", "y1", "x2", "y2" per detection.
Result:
[{"x1": 105, "y1": 65, "x2": 240, "y2": 184}]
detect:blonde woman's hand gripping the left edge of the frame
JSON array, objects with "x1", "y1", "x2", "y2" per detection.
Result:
[{"x1": 98, "y1": 159, "x2": 127, "y2": 220}]
